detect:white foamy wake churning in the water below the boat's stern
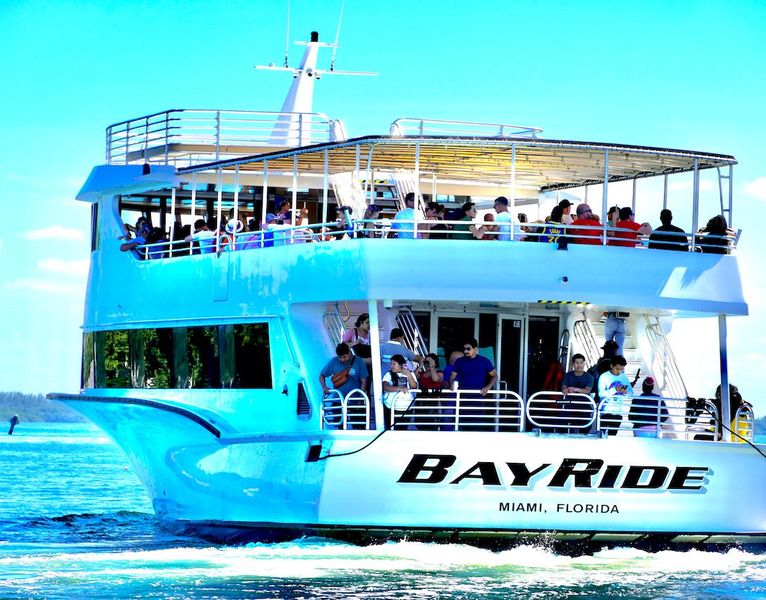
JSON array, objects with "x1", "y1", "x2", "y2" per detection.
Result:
[{"x1": 0, "y1": 532, "x2": 766, "y2": 598}]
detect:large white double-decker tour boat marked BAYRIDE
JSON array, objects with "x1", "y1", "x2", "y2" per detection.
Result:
[{"x1": 50, "y1": 34, "x2": 766, "y2": 548}]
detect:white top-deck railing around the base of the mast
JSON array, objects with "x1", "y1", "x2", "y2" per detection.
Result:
[{"x1": 106, "y1": 109, "x2": 345, "y2": 166}]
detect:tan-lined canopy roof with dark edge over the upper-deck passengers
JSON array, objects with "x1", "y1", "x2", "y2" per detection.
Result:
[{"x1": 179, "y1": 136, "x2": 736, "y2": 192}]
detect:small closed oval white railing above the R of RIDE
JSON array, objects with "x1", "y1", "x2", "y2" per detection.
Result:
[{"x1": 526, "y1": 392, "x2": 596, "y2": 433}]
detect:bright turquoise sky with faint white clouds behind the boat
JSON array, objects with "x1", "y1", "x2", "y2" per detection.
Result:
[{"x1": 0, "y1": 0, "x2": 766, "y2": 401}]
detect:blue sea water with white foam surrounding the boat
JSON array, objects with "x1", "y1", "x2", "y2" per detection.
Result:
[{"x1": 0, "y1": 423, "x2": 766, "y2": 599}]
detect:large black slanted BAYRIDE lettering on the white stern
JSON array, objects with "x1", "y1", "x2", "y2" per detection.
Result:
[{"x1": 398, "y1": 454, "x2": 710, "y2": 491}]
